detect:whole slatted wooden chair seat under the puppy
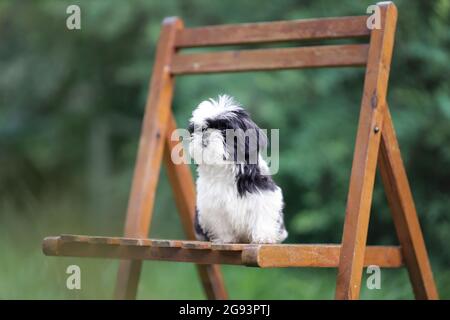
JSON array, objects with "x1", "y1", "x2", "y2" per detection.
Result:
[{"x1": 43, "y1": 235, "x2": 403, "y2": 268}]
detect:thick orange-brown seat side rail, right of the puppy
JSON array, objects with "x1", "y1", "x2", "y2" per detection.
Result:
[{"x1": 246, "y1": 245, "x2": 403, "y2": 268}]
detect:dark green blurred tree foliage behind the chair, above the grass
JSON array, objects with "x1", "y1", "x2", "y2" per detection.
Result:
[{"x1": 0, "y1": 0, "x2": 450, "y2": 263}]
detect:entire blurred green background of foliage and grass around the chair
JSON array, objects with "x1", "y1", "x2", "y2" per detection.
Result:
[{"x1": 0, "y1": 0, "x2": 450, "y2": 299}]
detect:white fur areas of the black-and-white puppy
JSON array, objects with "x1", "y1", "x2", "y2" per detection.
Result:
[{"x1": 189, "y1": 96, "x2": 287, "y2": 243}]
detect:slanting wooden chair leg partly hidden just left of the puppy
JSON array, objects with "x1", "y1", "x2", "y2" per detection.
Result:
[{"x1": 164, "y1": 114, "x2": 227, "y2": 300}]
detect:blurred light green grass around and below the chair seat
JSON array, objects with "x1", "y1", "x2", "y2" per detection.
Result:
[{"x1": 0, "y1": 188, "x2": 450, "y2": 299}]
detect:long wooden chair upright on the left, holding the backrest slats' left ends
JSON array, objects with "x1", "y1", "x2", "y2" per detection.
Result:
[{"x1": 115, "y1": 18, "x2": 183, "y2": 299}]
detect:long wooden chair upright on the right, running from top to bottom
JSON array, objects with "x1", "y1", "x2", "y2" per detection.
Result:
[{"x1": 336, "y1": 2, "x2": 397, "y2": 299}]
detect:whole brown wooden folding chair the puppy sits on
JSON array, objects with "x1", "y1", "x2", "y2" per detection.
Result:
[{"x1": 43, "y1": 2, "x2": 438, "y2": 299}]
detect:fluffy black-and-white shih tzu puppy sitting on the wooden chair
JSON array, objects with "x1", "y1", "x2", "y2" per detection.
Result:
[{"x1": 189, "y1": 95, "x2": 287, "y2": 243}]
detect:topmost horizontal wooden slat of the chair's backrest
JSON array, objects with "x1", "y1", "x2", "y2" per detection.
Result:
[{"x1": 175, "y1": 16, "x2": 370, "y2": 48}]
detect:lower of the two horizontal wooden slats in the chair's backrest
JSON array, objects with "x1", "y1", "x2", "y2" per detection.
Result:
[{"x1": 171, "y1": 44, "x2": 368, "y2": 75}]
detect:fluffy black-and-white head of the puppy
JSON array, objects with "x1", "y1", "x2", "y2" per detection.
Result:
[{"x1": 189, "y1": 95, "x2": 267, "y2": 165}]
